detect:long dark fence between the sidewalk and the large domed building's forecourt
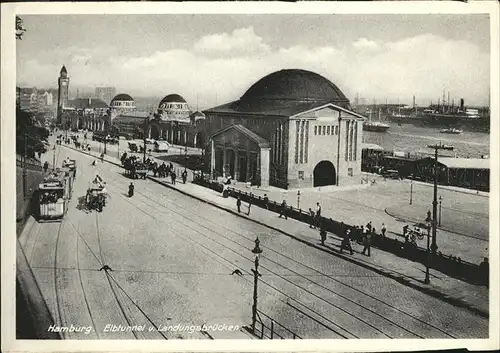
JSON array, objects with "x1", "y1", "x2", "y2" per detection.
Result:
[{"x1": 193, "y1": 174, "x2": 489, "y2": 285}]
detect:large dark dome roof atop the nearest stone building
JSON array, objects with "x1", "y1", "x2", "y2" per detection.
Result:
[{"x1": 241, "y1": 69, "x2": 349, "y2": 102}]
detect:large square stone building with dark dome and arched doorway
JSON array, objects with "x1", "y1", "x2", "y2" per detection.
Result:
[{"x1": 204, "y1": 69, "x2": 364, "y2": 188}]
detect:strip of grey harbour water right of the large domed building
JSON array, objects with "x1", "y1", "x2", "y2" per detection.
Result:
[{"x1": 363, "y1": 123, "x2": 490, "y2": 158}]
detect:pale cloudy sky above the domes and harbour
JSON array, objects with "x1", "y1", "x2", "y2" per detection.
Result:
[{"x1": 16, "y1": 14, "x2": 490, "y2": 109}]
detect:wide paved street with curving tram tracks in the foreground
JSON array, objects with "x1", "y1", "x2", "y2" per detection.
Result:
[{"x1": 20, "y1": 146, "x2": 488, "y2": 339}]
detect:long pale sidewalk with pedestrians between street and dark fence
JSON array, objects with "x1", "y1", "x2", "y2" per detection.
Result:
[{"x1": 60, "y1": 140, "x2": 489, "y2": 317}]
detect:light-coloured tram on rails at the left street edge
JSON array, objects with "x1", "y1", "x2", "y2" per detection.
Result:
[{"x1": 36, "y1": 170, "x2": 72, "y2": 222}]
